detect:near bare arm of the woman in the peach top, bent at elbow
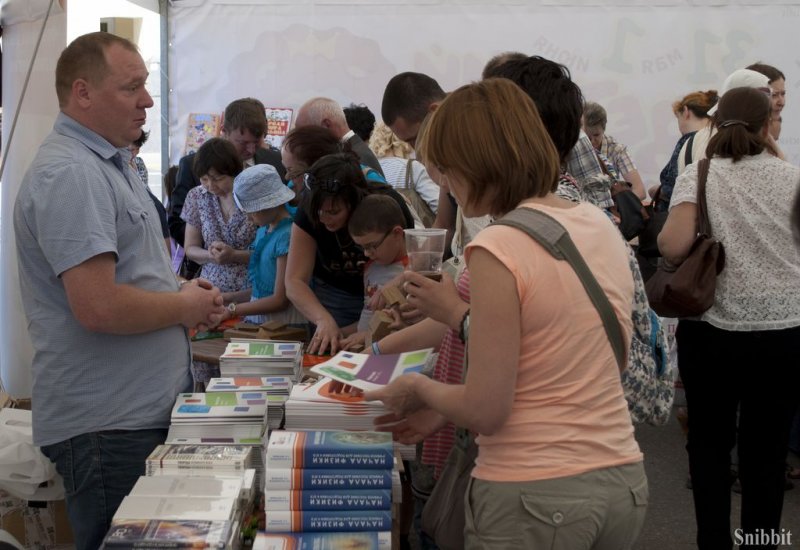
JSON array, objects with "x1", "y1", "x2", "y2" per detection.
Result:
[{"x1": 366, "y1": 248, "x2": 521, "y2": 435}]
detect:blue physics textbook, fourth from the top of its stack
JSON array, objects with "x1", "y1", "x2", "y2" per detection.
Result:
[{"x1": 264, "y1": 510, "x2": 392, "y2": 533}]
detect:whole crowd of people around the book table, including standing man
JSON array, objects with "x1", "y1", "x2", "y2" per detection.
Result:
[{"x1": 14, "y1": 32, "x2": 800, "y2": 550}]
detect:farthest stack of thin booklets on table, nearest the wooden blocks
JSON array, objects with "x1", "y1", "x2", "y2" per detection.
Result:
[{"x1": 219, "y1": 339, "x2": 303, "y2": 382}]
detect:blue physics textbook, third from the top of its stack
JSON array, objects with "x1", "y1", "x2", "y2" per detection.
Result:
[{"x1": 264, "y1": 489, "x2": 392, "y2": 512}]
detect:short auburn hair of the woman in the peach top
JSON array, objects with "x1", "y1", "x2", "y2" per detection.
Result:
[{"x1": 417, "y1": 78, "x2": 559, "y2": 216}]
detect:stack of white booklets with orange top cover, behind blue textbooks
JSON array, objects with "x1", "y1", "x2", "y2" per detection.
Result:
[{"x1": 285, "y1": 378, "x2": 416, "y2": 460}]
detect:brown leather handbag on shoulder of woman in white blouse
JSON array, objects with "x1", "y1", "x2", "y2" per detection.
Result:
[{"x1": 645, "y1": 159, "x2": 725, "y2": 317}]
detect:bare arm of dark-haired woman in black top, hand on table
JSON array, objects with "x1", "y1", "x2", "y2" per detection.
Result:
[{"x1": 285, "y1": 224, "x2": 339, "y2": 353}]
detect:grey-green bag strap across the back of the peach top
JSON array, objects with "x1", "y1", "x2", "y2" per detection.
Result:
[{"x1": 492, "y1": 208, "x2": 627, "y2": 371}]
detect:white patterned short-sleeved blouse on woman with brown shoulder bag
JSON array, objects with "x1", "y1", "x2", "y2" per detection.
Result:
[{"x1": 670, "y1": 152, "x2": 800, "y2": 331}]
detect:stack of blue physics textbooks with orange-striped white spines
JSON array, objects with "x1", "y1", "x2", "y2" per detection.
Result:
[{"x1": 262, "y1": 430, "x2": 400, "y2": 548}]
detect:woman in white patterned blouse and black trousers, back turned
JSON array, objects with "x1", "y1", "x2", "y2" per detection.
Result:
[{"x1": 658, "y1": 87, "x2": 800, "y2": 549}]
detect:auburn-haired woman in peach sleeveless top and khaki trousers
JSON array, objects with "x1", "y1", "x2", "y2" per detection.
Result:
[{"x1": 366, "y1": 79, "x2": 648, "y2": 549}]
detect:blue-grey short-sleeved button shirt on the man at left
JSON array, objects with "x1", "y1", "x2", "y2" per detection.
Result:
[{"x1": 14, "y1": 113, "x2": 191, "y2": 446}]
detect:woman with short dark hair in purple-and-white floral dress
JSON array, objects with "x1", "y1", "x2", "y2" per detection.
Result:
[{"x1": 181, "y1": 138, "x2": 256, "y2": 292}]
